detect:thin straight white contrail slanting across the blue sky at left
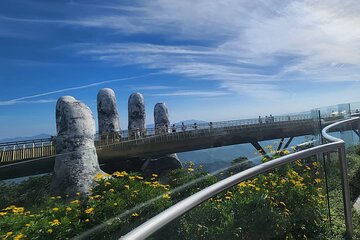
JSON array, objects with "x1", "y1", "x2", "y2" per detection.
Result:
[{"x1": 0, "y1": 73, "x2": 156, "y2": 106}]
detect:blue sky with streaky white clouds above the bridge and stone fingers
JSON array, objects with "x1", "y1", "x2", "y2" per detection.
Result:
[{"x1": 0, "y1": 0, "x2": 360, "y2": 138}]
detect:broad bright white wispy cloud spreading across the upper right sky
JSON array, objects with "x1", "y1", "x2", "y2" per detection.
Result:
[{"x1": 69, "y1": 0, "x2": 360, "y2": 96}]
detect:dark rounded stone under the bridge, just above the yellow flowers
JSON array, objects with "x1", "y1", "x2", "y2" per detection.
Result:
[{"x1": 141, "y1": 153, "x2": 183, "y2": 174}]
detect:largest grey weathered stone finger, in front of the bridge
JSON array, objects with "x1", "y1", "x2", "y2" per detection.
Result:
[{"x1": 51, "y1": 97, "x2": 103, "y2": 195}]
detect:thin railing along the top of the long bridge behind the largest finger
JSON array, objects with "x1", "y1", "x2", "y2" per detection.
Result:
[{"x1": 0, "y1": 114, "x2": 312, "y2": 162}]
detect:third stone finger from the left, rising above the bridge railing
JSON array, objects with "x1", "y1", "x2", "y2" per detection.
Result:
[{"x1": 128, "y1": 93, "x2": 146, "y2": 132}]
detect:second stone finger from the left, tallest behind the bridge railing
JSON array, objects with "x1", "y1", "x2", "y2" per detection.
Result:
[{"x1": 97, "y1": 88, "x2": 121, "y2": 134}]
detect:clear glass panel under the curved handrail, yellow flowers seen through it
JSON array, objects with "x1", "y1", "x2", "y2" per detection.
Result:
[{"x1": 152, "y1": 157, "x2": 329, "y2": 239}]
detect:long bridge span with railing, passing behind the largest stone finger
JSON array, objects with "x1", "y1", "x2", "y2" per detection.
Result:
[{"x1": 0, "y1": 115, "x2": 358, "y2": 179}]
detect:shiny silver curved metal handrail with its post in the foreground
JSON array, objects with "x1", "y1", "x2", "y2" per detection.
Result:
[{"x1": 121, "y1": 118, "x2": 360, "y2": 240}]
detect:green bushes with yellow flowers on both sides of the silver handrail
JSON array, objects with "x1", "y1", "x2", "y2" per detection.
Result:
[{"x1": 0, "y1": 155, "x2": 334, "y2": 239}]
